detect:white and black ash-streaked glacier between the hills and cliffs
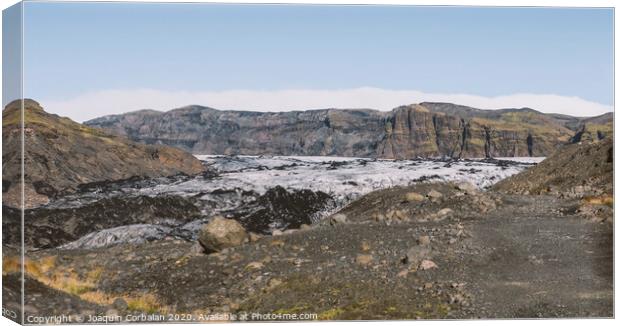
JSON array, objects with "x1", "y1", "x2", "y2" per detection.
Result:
[{"x1": 2, "y1": 156, "x2": 537, "y2": 250}]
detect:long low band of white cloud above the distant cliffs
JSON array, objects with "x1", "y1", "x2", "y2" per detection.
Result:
[{"x1": 7, "y1": 87, "x2": 614, "y2": 122}]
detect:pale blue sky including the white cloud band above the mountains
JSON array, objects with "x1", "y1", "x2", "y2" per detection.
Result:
[{"x1": 3, "y1": 2, "x2": 614, "y2": 121}]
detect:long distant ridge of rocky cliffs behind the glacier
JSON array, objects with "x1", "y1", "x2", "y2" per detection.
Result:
[{"x1": 86, "y1": 103, "x2": 613, "y2": 159}]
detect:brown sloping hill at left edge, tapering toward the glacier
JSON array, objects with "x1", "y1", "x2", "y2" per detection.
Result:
[{"x1": 2, "y1": 99, "x2": 203, "y2": 207}]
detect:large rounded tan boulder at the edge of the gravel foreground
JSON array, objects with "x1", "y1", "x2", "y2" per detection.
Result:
[{"x1": 198, "y1": 216, "x2": 248, "y2": 253}]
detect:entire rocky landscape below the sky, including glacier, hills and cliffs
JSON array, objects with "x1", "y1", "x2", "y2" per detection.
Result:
[{"x1": 2, "y1": 101, "x2": 613, "y2": 323}]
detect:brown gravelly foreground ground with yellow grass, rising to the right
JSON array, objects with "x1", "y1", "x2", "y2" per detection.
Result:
[{"x1": 3, "y1": 136, "x2": 613, "y2": 322}]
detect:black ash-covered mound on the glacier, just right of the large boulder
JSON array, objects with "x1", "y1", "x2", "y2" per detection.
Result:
[{"x1": 234, "y1": 186, "x2": 335, "y2": 234}]
